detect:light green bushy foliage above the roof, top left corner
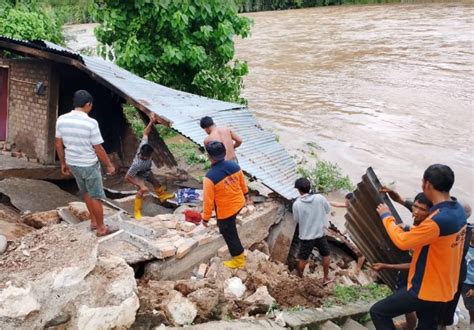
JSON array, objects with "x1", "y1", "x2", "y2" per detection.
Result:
[{"x1": 0, "y1": 0, "x2": 63, "y2": 44}]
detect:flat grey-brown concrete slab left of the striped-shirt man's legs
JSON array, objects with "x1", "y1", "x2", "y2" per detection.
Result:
[{"x1": 0, "y1": 178, "x2": 78, "y2": 212}]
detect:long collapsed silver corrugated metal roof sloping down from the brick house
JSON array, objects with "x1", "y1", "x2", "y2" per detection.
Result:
[{"x1": 0, "y1": 37, "x2": 298, "y2": 200}]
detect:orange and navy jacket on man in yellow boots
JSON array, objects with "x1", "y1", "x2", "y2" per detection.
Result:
[{"x1": 202, "y1": 160, "x2": 248, "y2": 221}]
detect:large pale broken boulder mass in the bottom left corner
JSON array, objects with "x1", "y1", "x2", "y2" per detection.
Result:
[{"x1": 0, "y1": 225, "x2": 138, "y2": 329}]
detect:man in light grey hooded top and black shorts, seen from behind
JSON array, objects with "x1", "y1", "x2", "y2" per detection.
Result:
[{"x1": 293, "y1": 178, "x2": 331, "y2": 285}]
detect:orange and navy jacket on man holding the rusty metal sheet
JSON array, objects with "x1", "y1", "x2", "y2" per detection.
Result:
[{"x1": 381, "y1": 201, "x2": 466, "y2": 302}]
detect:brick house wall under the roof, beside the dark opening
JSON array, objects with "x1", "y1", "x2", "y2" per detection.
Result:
[{"x1": 0, "y1": 58, "x2": 55, "y2": 164}]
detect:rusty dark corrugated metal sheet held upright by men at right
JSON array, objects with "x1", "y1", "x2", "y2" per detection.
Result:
[{"x1": 346, "y1": 167, "x2": 410, "y2": 289}]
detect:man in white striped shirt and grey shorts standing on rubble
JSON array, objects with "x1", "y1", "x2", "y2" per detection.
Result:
[{"x1": 56, "y1": 90, "x2": 117, "y2": 236}]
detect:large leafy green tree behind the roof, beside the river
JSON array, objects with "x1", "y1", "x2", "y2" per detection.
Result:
[{"x1": 95, "y1": 0, "x2": 251, "y2": 102}]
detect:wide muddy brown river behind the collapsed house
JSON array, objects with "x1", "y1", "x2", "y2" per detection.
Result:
[{"x1": 236, "y1": 3, "x2": 474, "y2": 202}]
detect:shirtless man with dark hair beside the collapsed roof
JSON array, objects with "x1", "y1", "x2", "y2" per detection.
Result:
[{"x1": 200, "y1": 116, "x2": 242, "y2": 163}]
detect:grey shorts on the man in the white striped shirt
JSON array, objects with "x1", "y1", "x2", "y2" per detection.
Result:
[{"x1": 69, "y1": 162, "x2": 105, "y2": 199}]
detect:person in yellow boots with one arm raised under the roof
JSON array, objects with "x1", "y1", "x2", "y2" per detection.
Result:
[{"x1": 125, "y1": 114, "x2": 174, "y2": 220}]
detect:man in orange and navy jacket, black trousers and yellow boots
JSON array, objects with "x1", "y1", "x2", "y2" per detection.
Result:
[{"x1": 202, "y1": 141, "x2": 248, "y2": 268}]
